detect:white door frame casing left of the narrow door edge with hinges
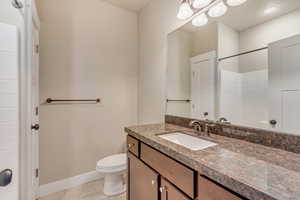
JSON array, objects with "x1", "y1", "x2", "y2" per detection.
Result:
[{"x1": 19, "y1": 0, "x2": 40, "y2": 200}]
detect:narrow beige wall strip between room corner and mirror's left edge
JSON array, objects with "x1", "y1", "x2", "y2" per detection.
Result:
[{"x1": 139, "y1": 0, "x2": 188, "y2": 123}]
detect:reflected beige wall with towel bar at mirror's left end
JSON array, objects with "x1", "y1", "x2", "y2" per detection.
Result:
[{"x1": 166, "y1": 29, "x2": 193, "y2": 117}]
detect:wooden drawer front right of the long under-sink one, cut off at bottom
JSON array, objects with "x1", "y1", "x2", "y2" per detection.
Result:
[{"x1": 198, "y1": 176, "x2": 243, "y2": 200}]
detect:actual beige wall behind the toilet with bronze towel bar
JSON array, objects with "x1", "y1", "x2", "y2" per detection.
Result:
[{"x1": 38, "y1": 0, "x2": 138, "y2": 184}]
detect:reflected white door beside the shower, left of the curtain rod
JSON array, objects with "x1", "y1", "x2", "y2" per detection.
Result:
[{"x1": 191, "y1": 51, "x2": 217, "y2": 120}]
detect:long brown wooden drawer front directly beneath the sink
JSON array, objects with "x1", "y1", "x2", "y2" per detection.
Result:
[{"x1": 141, "y1": 143, "x2": 195, "y2": 199}]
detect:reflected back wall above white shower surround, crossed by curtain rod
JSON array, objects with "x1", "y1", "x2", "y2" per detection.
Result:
[{"x1": 239, "y1": 10, "x2": 300, "y2": 73}]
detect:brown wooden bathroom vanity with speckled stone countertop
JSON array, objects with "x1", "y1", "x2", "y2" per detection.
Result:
[{"x1": 125, "y1": 124, "x2": 300, "y2": 200}]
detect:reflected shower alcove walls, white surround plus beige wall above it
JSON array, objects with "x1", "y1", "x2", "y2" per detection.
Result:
[{"x1": 219, "y1": 10, "x2": 300, "y2": 128}]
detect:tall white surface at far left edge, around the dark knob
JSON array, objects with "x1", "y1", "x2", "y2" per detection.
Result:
[{"x1": 0, "y1": 23, "x2": 19, "y2": 200}]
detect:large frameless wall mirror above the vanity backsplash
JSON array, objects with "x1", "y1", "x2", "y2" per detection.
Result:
[{"x1": 166, "y1": 0, "x2": 300, "y2": 135}]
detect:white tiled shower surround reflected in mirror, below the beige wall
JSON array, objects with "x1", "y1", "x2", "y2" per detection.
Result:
[{"x1": 220, "y1": 70, "x2": 268, "y2": 128}]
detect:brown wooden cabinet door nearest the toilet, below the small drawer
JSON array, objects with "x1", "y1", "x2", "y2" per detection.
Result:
[{"x1": 128, "y1": 153, "x2": 159, "y2": 200}]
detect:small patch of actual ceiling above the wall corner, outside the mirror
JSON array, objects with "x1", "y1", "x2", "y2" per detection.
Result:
[{"x1": 105, "y1": 0, "x2": 150, "y2": 12}]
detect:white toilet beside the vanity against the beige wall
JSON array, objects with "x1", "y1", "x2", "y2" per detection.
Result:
[{"x1": 96, "y1": 153, "x2": 127, "y2": 196}]
